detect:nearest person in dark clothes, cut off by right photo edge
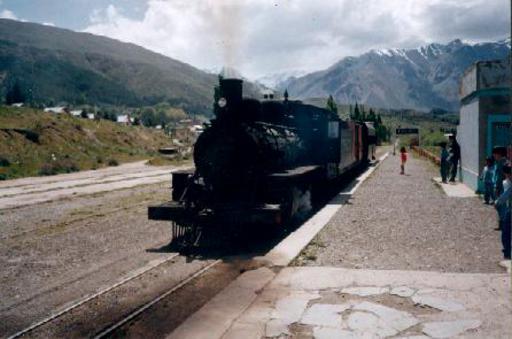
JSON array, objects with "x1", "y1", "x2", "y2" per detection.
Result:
[{"x1": 495, "y1": 165, "x2": 512, "y2": 264}]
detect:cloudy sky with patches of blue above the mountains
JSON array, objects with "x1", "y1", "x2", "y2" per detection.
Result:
[{"x1": 0, "y1": 0, "x2": 510, "y2": 78}]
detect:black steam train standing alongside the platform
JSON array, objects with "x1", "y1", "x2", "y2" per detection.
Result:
[{"x1": 148, "y1": 79, "x2": 375, "y2": 240}]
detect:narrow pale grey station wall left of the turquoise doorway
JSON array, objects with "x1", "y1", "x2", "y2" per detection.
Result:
[{"x1": 457, "y1": 99, "x2": 481, "y2": 191}]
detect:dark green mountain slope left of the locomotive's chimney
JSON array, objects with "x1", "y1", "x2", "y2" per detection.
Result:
[{"x1": 0, "y1": 19, "x2": 222, "y2": 113}]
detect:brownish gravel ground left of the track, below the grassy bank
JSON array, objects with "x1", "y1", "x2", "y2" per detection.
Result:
[{"x1": 0, "y1": 183, "x2": 176, "y2": 337}]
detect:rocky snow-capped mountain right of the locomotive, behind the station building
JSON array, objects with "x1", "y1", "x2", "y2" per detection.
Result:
[{"x1": 277, "y1": 39, "x2": 510, "y2": 111}]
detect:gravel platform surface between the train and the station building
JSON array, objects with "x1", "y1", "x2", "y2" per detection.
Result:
[{"x1": 297, "y1": 155, "x2": 502, "y2": 272}]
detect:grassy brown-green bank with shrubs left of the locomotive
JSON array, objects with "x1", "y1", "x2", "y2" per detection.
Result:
[{"x1": 0, "y1": 106, "x2": 171, "y2": 180}]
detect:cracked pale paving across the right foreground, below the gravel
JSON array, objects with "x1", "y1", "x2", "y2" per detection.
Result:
[{"x1": 217, "y1": 267, "x2": 512, "y2": 339}]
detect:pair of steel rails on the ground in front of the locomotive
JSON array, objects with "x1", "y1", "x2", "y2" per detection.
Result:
[{"x1": 8, "y1": 253, "x2": 221, "y2": 339}]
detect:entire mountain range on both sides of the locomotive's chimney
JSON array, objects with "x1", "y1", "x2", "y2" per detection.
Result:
[{"x1": 0, "y1": 19, "x2": 510, "y2": 115}]
